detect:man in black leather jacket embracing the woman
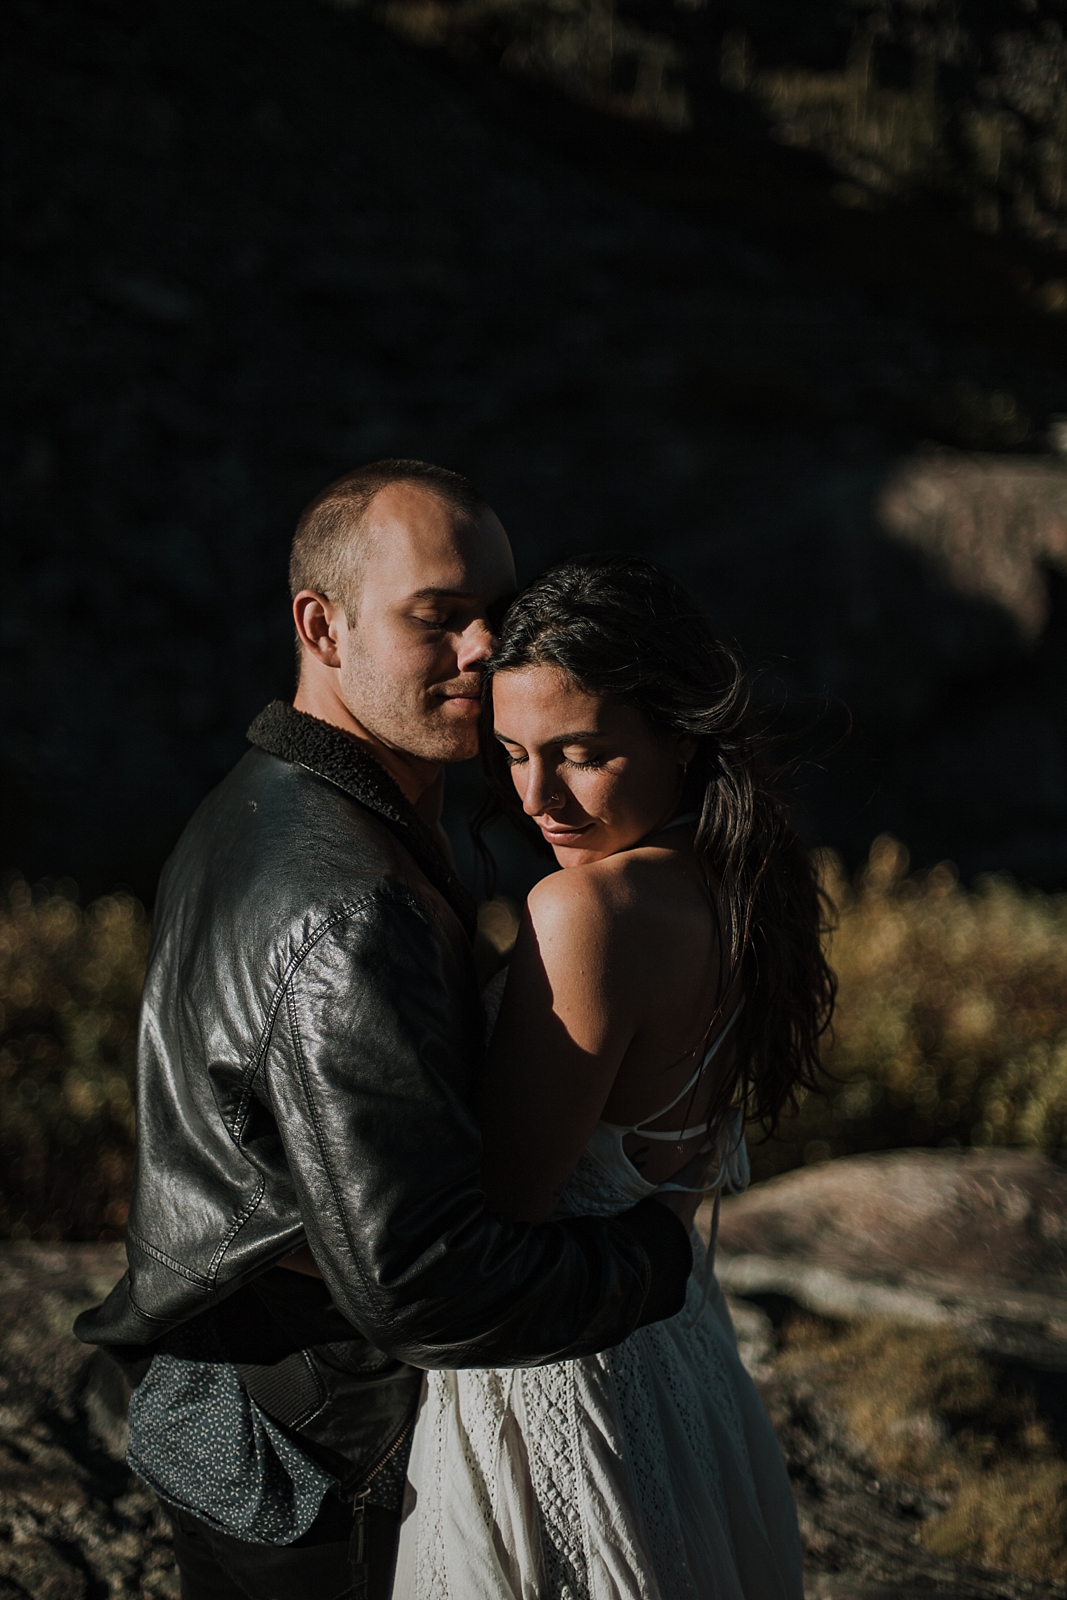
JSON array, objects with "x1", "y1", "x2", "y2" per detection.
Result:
[{"x1": 77, "y1": 461, "x2": 693, "y2": 1600}]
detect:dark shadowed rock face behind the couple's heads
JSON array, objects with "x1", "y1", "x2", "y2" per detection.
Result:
[{"x1": 3, "y1": 0, "x2": 1067, "y2": 894}]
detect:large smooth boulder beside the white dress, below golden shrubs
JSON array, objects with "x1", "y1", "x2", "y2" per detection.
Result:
[{"x1": 717, "y1": 1149, "x2": 1067, "y2": 1371}]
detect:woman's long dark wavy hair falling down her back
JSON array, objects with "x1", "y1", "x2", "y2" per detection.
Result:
[{"x1": 475, "y1": 555, "x2": 835, "y2": 1133}]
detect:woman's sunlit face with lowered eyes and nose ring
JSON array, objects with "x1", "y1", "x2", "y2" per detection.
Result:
[{"x1": 493, "y1": 666, "x2": 696, "y2": 867}]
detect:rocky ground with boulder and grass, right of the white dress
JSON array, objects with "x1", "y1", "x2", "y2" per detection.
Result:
[{"x1": 705, "y1": 1150, "x2": 1067, "y2": 1600}]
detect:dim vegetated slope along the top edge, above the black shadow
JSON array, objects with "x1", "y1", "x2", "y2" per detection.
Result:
[{"x1": 375, "y1": 0, "x2": 1067, "y2": 251}]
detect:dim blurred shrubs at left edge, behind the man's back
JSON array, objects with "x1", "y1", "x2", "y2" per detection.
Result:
[{"x1": 0, "y1": 878, "x2": 149, "y2": 1238}]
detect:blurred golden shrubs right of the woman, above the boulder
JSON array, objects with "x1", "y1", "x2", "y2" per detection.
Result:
[{"x1": 752, "y1": 838, "x2": 1067, "y2": 1176}]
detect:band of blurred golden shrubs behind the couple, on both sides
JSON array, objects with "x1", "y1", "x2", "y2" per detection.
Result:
[{"x1": 0, "y1": 838, "x2": 1067, "y2": 1238}]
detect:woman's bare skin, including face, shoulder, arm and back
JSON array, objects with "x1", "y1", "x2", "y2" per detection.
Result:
[{"x1": 482, "y1": 662, "x2": 735, "y2": 1222}]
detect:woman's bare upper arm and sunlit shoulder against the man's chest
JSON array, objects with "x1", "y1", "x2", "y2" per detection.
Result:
[{"x1": 482, "y1": 867, "x2": 641, "y2": 1221}]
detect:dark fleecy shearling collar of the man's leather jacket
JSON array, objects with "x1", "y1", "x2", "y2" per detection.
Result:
[{"x1": 246, "y1": 701, "x2": 477, "y2": 938}]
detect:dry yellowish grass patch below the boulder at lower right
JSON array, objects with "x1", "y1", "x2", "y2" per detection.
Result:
[{"x1": 782, "y1": 1317, "x2": 1067, "y2": 1579}]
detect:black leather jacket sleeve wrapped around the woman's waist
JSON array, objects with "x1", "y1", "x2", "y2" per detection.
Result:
[{"x1": 262, "y1": 890, "x2": 691, "y2": 1366}]
